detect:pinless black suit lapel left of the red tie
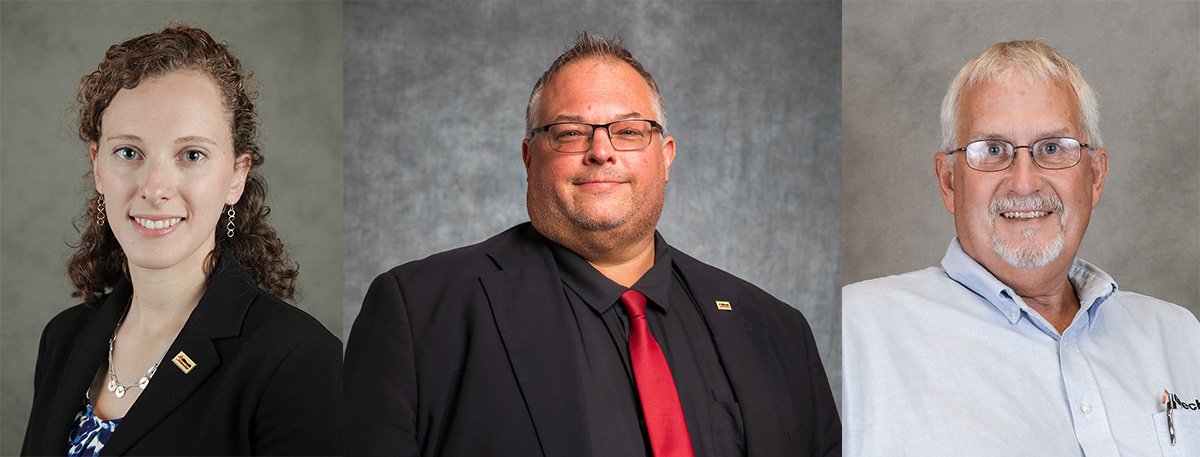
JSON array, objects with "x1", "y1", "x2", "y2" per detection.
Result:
[{"x1": 480, "y1": 227, "x2": 590, "y2": 456}]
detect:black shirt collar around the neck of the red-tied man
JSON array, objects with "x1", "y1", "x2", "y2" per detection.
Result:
[{"x1": 546, "y1": 231, "x2": 671, "y2": 313}]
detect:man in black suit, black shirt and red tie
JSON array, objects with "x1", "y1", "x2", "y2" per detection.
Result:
[{"x1": 346, "y1": 32, "x2": 841, "y2": 457}]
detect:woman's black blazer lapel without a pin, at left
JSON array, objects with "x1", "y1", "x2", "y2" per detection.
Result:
[{"x1": 42, "y1": 281, "x2": 133, "y2": 451}]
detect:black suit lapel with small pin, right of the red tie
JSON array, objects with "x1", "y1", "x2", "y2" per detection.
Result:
[{"x1": 674, "y1": 251, "x2": 794, "y2": 457}]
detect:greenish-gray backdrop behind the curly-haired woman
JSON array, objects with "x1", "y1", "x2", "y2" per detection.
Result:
[{"x1": 0, "y1": 1, "x2": 342, "y2": 448}]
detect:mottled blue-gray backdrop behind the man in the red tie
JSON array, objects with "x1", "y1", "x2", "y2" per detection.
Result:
[{"x1": 343, "y1": 1, "x2": 841, "y2": 398}]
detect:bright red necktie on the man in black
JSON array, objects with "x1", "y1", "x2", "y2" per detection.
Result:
[{"x1": 620, "y1": 289, "x2": 695, "y2": 457}]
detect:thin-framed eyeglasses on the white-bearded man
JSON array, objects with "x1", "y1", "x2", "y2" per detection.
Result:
[{"x1": 950, "y1": 138, "x2": 1091, "y2": 172}]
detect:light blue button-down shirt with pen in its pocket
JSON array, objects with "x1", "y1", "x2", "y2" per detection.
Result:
[{"x1": 841, "y1": 239, "x2": 1200, "y2": 457}]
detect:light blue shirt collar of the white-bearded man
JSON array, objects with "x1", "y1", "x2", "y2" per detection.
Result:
[{"x1": 942, "y1": 237, "x2": 1117, "y2": 325}]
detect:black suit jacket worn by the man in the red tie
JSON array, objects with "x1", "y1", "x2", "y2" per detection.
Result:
[{"x1": 346, "y1": 223, "x2": 841, "y2": 457}]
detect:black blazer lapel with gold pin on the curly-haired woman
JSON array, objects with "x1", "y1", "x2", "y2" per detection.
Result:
[{"x1": 103, "y1": 249, "x2": 258, "y2": 455}]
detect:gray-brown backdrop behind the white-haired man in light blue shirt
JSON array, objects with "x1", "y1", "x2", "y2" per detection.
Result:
[{"x1": 841, "y1": 1, "x2": 1200, "y2": 314}]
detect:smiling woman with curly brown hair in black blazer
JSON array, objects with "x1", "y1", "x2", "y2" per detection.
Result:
[{"x1": 22, "y1": 25, "x2": 342, "y2": 456}]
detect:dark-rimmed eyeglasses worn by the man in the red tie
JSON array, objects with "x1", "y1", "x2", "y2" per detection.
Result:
[{"x1": 529, "y1": 119, "x2": 662, "y2": 154}]
